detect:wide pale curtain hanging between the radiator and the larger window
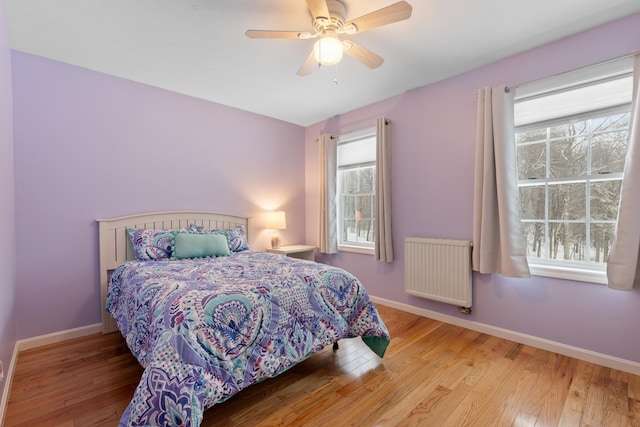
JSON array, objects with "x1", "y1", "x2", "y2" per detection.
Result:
[{"x1": 472, "y1": 86, "x2": 531, "y2": 277}]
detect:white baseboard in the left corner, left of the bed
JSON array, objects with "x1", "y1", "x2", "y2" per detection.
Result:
[{"x1": 0, "y1": 323, "x2": 102, "y2": 426}]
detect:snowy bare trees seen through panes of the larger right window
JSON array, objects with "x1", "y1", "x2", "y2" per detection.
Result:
[{"x1": 516, "y1": 111, "x2": 630, "y2": 265}]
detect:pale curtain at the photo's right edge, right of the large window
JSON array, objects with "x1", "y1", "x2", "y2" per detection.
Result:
[{"x1": 607, "y1": 54, "x2": 640, "y2": 291}]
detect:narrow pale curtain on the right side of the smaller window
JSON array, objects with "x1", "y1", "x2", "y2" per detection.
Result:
[{"x1": 375, "y1": 117, "x2": 393, "y2": 262}]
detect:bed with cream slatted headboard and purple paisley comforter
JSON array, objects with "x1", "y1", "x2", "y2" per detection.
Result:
[{"x1": 98, "y1": 212, "x2": 389, "y2": 426}]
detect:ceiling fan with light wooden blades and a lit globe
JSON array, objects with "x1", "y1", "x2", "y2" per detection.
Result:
[{"x1": 245, "y1": 0, "x2": 412, "y2": 76}]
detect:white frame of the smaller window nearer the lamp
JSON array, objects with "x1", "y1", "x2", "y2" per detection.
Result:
[{"x1": 336, "y1": 126, "x2": 377, "y2": 255}]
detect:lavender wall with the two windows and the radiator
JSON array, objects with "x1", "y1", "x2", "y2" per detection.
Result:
[{"x1": 305, "y1": 14, "x2": 640, "y2": 362}]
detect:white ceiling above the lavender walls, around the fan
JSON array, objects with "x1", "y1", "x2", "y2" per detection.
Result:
[{"x1": 3, "y1": 0, "x2": 640, "y2": 126}]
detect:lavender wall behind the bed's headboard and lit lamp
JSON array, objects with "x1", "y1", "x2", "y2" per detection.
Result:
[{"x1": 12, "y1": 52, "x2": 304, "y2": 339}]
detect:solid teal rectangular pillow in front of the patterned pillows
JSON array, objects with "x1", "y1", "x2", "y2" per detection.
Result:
[{"x1": 171, "y1": 230, "x2": 231, "y2": 259}]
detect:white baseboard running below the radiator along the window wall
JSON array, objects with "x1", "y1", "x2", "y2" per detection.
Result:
[{"x1": 371, "y1": 296, "x2": 640, "y2": 375}]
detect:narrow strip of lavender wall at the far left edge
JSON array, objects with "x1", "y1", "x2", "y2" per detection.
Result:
[{"x1": 0, "y1": 4, "x2": 16, "y2": 404}]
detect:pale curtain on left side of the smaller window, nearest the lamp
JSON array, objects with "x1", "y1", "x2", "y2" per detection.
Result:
[{"x1": 318, "y1": 134, "x2": 338, "y2": 254}]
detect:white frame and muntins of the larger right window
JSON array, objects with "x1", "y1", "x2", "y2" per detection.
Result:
[{"x1": 515, "y1": 57, "x2": 633, "y2": 284}]
